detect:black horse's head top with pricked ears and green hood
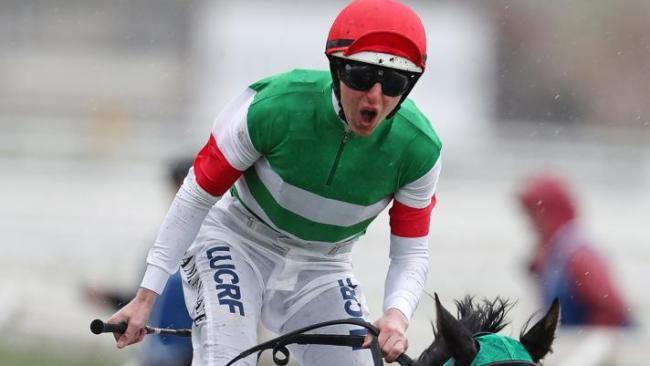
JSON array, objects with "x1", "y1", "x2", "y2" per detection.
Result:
[{"x1": 413, "y1": 294, "x2": 560, "y2": 366}]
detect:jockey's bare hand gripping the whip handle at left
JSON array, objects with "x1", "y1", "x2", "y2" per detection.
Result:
[{"x1": 106, "y1": 287, "x2": 158, "y2": 348}]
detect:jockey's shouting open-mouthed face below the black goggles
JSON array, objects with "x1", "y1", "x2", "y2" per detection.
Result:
[{"x1": 340, "y1": 81, "x2": 401, "y2": 136}]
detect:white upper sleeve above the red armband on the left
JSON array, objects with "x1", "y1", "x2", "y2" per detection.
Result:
[{"x1": 212, "y1": 88, "x2": 261, "y2": 171}]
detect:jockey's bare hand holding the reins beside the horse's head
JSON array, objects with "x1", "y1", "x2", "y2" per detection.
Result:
[{"x1": 363, "y1": 308, "x2": 409, "y2": 362}]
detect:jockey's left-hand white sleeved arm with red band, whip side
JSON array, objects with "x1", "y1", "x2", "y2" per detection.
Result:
[{"x1": 141, "y1": 89, "x2": 261, "y2": 294}]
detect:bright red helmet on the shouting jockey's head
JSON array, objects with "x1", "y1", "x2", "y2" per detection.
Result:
[{"x1": 325, "y1": 0, "x2": 427, "y2": 73}]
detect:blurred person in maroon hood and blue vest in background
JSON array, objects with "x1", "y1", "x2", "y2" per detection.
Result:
[{"x1": 518, "y1": 175, "x2": 629, "y2": 326}]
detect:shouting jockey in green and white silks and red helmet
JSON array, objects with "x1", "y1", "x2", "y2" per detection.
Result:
[{"x1": 109, "y1": 0, "x2": 441, "y2": 365}]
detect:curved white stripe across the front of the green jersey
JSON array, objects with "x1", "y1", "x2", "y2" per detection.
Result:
[{"x1": 255, "y1": 157, "x2": 391, "y2": 227}]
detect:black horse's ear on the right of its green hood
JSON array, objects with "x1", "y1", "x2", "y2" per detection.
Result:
[{"x1": 519, "y1": 298, "x2": 560, "y2": 362}]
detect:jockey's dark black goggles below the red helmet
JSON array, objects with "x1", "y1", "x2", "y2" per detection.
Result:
[{"x1": 337, "y1": 60, "x2": 418, "y2": 97}]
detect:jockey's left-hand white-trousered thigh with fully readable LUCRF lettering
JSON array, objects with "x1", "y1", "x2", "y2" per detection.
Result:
[{"x1": 181, "y1": 237, "x2": 262, "y2": 366}]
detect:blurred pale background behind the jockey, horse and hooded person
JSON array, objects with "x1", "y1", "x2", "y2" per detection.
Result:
[{"x1": 0, "y1": 0, "x2": 650, "y2": 366}]
